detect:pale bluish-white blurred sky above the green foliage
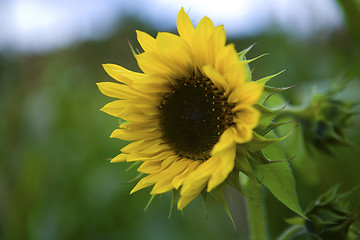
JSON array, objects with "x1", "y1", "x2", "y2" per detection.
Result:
[{"x1": 0, "y1": 0, "x2": 343, "y2": 52}]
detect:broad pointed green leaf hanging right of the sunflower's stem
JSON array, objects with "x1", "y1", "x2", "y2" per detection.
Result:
[{"x1": 253, "y1": 162, "x2": 306, "y2": 218}]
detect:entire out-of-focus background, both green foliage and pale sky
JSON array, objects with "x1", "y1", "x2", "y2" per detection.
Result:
[{"x1": 0, "y1": 0, "x2": 360, "y2": 240}]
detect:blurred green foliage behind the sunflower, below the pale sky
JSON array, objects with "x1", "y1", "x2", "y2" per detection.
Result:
[{"x1": 0, "y1": 6, "x2": 360, "y2": 239}]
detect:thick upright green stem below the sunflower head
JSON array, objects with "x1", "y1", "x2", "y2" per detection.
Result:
[{"x1": 245, "y1": 179, "x2": 267, "y2": 240}]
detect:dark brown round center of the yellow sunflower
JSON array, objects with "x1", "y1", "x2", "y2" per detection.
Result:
[{"x1": 159, "y1": 76, "x2": 232, "y2": 160}]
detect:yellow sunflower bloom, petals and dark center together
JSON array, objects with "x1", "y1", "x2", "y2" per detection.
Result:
[{"x1": 98, "y1": 9, "x2": 264, "y2": 210}]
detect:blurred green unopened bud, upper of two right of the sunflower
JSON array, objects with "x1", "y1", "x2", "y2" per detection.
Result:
[{"x1": 285, "y1": 79, "x2": 355, "y2": 155}]
